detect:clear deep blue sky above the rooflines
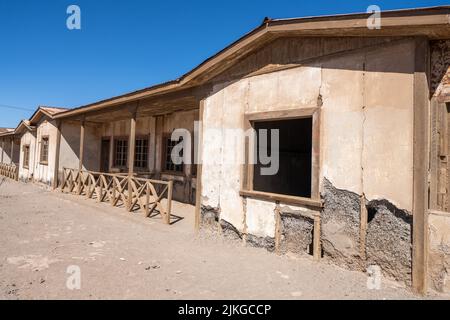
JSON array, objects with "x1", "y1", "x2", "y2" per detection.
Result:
[{"x1": 0, "y1": 0, "x2": 450, "y2": 127}]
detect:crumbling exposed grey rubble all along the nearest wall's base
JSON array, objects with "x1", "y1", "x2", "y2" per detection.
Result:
[{"x1": 201, "y1": 179, "x2": 414, "y2": 286}]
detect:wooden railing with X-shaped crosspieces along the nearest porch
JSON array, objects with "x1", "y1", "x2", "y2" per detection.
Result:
[{"x1": 61, "y1": 168, "x2": 173, "y2": 224}]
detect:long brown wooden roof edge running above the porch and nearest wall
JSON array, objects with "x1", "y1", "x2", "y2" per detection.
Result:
[{"x1": 54, "y1": 6, "x2": 450, "y2": 119}]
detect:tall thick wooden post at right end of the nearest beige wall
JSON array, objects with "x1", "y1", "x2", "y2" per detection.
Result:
[{"x1": 412, "y1": 38, "x2": 429, "y2": 294}]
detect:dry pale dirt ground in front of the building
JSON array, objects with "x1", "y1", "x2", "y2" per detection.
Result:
[{"x1": 0, "y1": 179, "x2": 442, "y2": 299}]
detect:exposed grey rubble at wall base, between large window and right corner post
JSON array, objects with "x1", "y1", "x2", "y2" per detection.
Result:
[{"x1": 322, "y1": 179, "x2": 412, "y2": 284}]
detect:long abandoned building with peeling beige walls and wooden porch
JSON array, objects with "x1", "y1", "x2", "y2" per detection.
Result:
[{"x1": 0, "y1": 7, "x2": 450, "y2": 293}]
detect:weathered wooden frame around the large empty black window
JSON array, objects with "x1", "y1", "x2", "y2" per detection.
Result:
[{"x1": 240, "y1": 107, "x2": 322, "y2": 208}]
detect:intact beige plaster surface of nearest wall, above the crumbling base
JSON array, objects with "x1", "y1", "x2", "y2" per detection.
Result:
[{"x1": 202, "y1": 41, "x2": 414, "y2": 236}]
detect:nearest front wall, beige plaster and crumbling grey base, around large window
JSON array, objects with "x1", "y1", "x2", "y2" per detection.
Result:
[{"x1": 201, "y1": 39, "x2": 414, "y2": 282}]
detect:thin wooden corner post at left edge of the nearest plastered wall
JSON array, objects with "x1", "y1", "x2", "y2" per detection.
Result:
[{"x1": 194, "y1": 100, "x2": 205, "y2": 232}]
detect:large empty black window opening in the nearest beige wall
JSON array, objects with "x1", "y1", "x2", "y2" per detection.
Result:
[{"x1": 253, "y1": 118, "x2": 312, "y2": 198}]
